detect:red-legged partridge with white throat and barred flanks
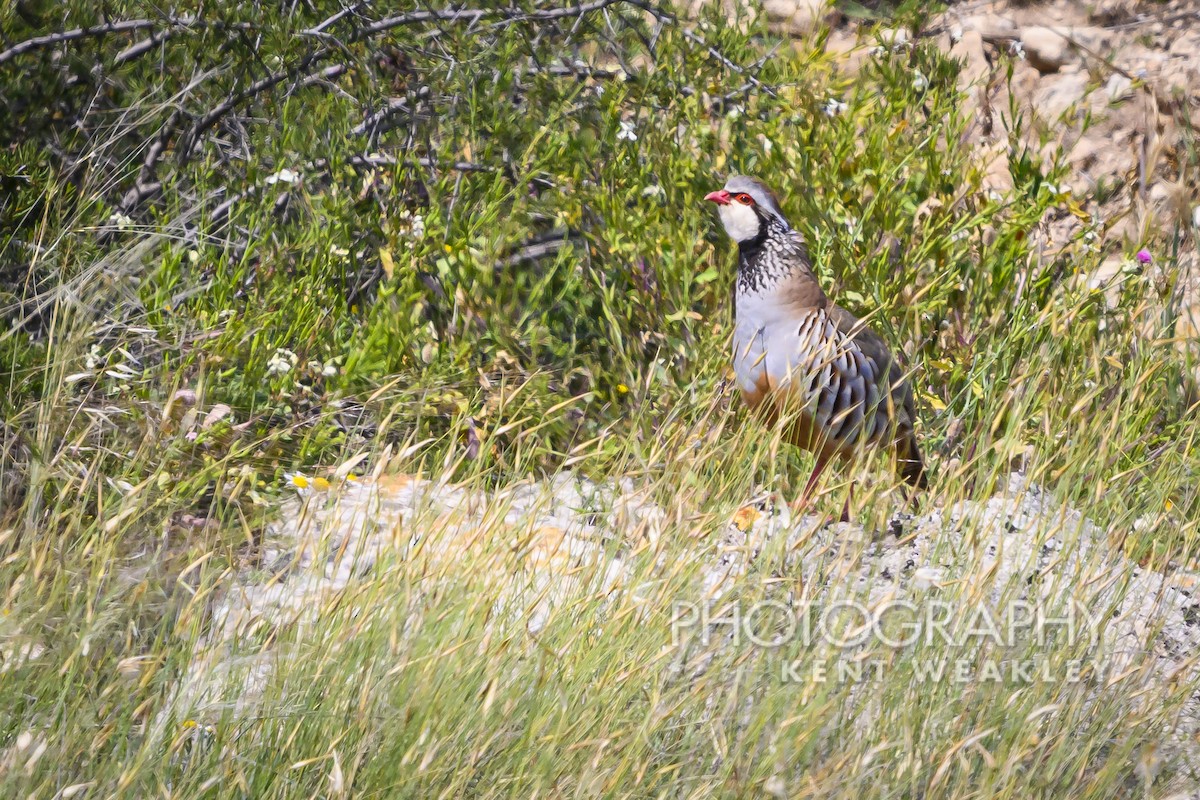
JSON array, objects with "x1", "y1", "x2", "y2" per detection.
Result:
[{"x1": 704, "y1": 175, "x2": 926, "y2": 518}]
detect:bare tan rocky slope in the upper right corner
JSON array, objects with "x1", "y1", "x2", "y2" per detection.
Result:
[{"x1": 766, "y1": 0, "x2": 1200, "y2": 357}]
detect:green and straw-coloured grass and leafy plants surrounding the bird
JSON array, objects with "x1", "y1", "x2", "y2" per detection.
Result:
[{"x1": 0, "y1": 0, "x2": 1198, "y2": 798}]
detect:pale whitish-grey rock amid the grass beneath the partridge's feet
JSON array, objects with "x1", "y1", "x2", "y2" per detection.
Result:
[{"x1": 166, "y1": 473, "x2": 1200, "y2": 796}]
